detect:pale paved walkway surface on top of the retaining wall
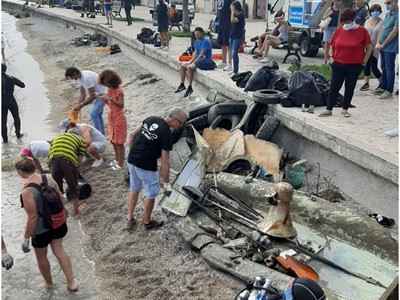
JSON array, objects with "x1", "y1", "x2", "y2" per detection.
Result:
[{"x1": 3, "y1": 0, "x2": 399, "y2": 171}]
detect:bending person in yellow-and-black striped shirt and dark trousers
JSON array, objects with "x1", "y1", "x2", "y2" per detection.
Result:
[{"x1": 48, "y1": 128, "x2": 86, "y2": 217}]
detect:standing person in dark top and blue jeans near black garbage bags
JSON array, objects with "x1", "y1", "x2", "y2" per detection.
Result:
[{"x1": 229, "y1": 1, "x2": 245, "y2": 75}]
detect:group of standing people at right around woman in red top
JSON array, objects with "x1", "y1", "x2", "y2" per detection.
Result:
[{"x1": 319, "y1": 0, "x2": 399, "y2": 117}]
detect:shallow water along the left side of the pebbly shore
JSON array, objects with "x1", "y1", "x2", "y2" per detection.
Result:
[{"x1": 1, "y1": 12, "x2": 99, "y2": 299}]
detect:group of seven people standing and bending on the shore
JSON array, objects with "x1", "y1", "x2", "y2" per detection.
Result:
[{"x1": 7, "y1": 59, "x2": 188, "y2": 291}]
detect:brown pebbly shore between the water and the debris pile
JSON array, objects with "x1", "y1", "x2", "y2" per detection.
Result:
[{"x1": 3, "y1": 12, "x2": 243, "y2": 299}]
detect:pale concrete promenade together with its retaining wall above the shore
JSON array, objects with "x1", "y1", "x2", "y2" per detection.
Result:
[{"x1": 2, "y1": 1, "x2": 398, "y2": 221}]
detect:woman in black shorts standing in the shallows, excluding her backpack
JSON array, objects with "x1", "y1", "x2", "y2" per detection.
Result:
[{"x1": 15, "y1": 155, "x2": 78, "y2": 292}]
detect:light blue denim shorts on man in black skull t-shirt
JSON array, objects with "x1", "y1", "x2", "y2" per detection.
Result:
[{"x1": 128, "y1": 164, "x2": 160, "y2": 199}]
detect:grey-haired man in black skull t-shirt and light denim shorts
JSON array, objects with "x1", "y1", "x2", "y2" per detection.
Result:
[{"x1": 126, "y1": 108, "x2": 187, "y2": 229}]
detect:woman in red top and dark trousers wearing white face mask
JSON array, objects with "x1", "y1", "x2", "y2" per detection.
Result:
[{"x1": 319, "y1": 8, "x2": 372, "y2": 117}]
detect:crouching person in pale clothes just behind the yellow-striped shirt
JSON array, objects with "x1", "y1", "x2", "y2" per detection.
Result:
[{"x1": 58, "y1": 119, "x2": 107, "y2": 168}]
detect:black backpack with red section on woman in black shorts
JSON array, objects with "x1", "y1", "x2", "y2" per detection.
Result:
[{"x1": 21, "y1": 174, "x2": 67, "y2": 229}]
